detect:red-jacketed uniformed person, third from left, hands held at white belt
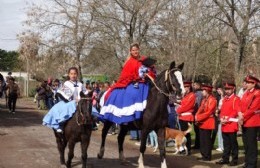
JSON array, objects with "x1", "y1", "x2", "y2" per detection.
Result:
[{"x1": 216, "y1": 83, "x2": 240, "y2": 166}]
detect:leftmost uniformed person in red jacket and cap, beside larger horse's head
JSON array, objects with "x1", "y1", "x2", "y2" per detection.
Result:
[{"x1": 176, "y1": 82, "x2": 196, "y2": 155}]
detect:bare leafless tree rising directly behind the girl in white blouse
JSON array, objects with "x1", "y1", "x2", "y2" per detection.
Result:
[{"x1": 22, "y1": 0, "x2": 95, "y2": 80}]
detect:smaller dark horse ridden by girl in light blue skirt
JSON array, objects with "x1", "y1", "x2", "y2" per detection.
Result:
[{"x1": 53, "y1": 92, "x2": 93, "y2": 168}]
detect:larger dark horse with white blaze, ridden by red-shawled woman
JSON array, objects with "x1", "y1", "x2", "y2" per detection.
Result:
[{"x1": 97, "y1": 61, "x2": 184, "y2": 168}]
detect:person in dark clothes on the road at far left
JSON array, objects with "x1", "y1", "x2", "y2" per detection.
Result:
[{"x1": 6, "y1": 77, "x2": 20, "y2": 114}]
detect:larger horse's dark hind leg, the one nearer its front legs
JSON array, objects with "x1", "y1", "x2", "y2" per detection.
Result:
[{"x1": 117, "y1": 125, "x2": 128, "y2": 163}]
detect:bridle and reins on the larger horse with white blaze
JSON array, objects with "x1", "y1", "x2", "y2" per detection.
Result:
[{"x1": 146, "y1": 68, "x2": 179, "y2": 97}]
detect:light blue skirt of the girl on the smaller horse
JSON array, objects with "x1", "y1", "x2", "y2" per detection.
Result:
[{"x1": 43, "y1": 101, "x2": 76, "y2": 129}]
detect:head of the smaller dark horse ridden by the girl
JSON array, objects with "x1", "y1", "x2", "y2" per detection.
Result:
[{"x1": 76, "y1": 92, "x2": 92, "y2": 125}]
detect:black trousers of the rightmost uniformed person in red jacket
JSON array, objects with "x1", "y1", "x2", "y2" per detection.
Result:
[{"x1": 242, "y1": 127, "x2": 259, "y2": 168}]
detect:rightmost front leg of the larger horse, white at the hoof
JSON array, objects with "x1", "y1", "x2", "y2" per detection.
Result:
[{"x1": 158, "y1": 128, "x2": 167, "y2": 168}]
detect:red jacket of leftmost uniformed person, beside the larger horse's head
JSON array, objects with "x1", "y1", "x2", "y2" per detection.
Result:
[{"x1": 176, "y1": 92, "x2": 196, "y2": 122}]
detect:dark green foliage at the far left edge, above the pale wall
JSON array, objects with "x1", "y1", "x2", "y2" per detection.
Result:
[{"x1": 0, "y1": 49, "x2": 19, "y2": 71}]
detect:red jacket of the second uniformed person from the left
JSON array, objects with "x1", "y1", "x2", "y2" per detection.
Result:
[{"x1": 195, "y1": 95, "x2": 217, "y2": 130}]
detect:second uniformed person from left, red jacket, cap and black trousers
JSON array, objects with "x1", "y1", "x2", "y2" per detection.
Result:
[{"x1": 195, "y1": 85, "x2": 217, "y2": 161}]
